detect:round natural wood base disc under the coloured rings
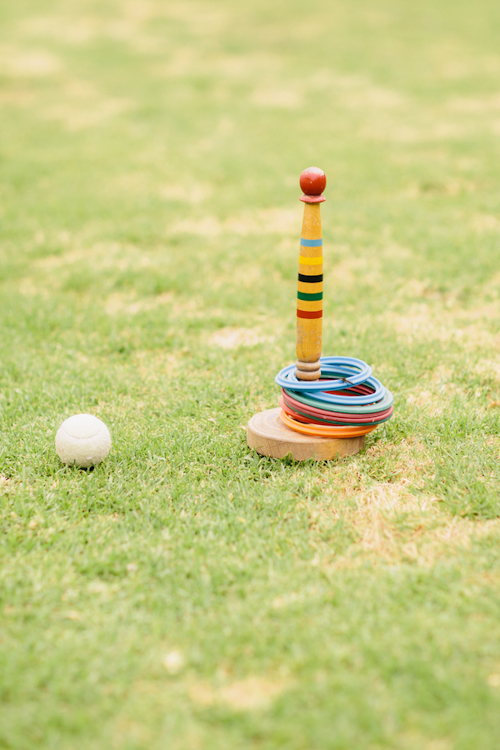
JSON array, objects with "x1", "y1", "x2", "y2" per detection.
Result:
[{"x1": 247, "y1": 407, "x2": 365, "y2": 461}]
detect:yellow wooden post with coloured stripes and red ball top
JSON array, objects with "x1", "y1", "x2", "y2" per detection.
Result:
[{"x1": 295, "y1": 167, "x2": 326, "y2": 380}]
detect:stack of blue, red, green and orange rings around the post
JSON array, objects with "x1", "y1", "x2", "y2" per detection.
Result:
[{"x1": 275, "y1": 357, "x2": 394, "y2": 438}]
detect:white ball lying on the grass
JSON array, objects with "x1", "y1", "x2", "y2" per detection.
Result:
[{"x1": 56, "y1": 414, "x2": 111, "y2": 469}]
